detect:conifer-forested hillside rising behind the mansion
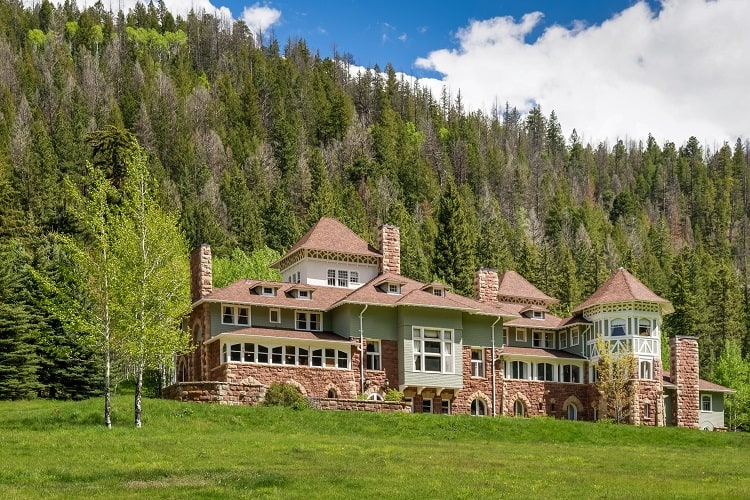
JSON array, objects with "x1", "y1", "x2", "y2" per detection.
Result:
[{"x1": 0, "y1": 0, "x2": 750, "y2": 416}]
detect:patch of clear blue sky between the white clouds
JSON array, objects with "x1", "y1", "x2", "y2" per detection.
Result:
[{"x1": 220, "y1": 0, "x2": 659, "y2": 77}]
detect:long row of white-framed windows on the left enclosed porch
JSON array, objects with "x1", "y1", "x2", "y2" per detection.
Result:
[{"x1": 221, "y1": 342, "x2": 349, "y2": 369}]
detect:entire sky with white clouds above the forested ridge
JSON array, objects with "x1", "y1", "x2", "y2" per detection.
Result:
[{"x1": 42, "y1": 0, "x2": 750, "y2": 149}]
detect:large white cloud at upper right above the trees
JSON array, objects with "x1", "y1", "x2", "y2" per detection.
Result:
[{"x1": 416, "y1": 0, "x2": 750, "y2": 146}]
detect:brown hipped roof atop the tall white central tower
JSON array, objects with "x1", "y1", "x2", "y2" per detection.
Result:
[{"x1": 274, "y1": 217, "x2": 381, "y2": 266}]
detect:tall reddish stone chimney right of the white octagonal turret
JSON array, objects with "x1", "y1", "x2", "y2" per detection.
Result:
[{"x1": 669, "y1": 336, "x2": 700, "y2": 429}]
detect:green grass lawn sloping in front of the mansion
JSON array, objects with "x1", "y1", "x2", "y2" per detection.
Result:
[{"x1": 0, "y1": 396, "x2": 750, "y2": 499}]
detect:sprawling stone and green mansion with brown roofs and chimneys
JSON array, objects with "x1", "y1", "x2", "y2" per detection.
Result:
[{"x1": 165, "y1": 219, "x2": 726, "y2": 428}]
